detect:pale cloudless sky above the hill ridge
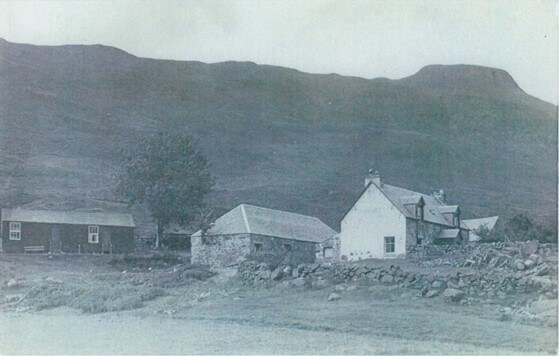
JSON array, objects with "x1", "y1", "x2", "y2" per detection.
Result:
[{"x1": 0, "y1": 0, "x2": 559, "y2": 104}]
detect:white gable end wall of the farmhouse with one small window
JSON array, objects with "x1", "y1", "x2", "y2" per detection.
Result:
[{"x1": 340, "y1": 184, "x2": 406, "y2": 261}]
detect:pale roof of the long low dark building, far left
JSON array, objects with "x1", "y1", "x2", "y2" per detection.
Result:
[{"x1": 2, "y1": 209, "x2": 136, "y2": 227}]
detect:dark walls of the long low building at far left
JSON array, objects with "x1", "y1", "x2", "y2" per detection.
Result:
[{"x1": 2, "y1": 221, "x2": 134, "y2": 253}]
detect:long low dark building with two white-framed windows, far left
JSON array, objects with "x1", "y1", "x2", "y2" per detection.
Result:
[{"x1": 0, "y1": 209, "x2": 135, "y2": 253}]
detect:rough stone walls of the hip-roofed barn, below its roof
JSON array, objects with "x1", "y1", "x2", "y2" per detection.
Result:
[{"x1": 191, "y1": 234, "x2": 317, "y2": 267}]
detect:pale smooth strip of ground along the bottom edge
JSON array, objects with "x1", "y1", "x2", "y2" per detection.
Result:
[{"x1": 0, "y1": 309, "x2": 540, "y2": 354}]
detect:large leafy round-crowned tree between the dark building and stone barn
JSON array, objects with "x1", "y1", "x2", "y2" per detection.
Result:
[{"x1": 117, "y1": 133, "x2": 213, "y2": 247}]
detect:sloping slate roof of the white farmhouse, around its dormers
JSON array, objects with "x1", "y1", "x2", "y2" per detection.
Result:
[{"x1": 380, "y1": 182, "x2": 457, "y2": 226}]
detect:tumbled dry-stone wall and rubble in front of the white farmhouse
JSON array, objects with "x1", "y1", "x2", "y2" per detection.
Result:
[{"x1": 238, "y1": 242, "x2": 557, "y2": 303}]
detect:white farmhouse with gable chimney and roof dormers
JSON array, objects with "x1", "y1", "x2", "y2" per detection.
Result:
[{"x1": 339, "y1": 171, "x2": 469, "y2": 261}]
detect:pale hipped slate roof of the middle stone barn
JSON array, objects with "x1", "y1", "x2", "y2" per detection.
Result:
[{"x1": 194, "y1": 204, "x2": 337, "y2": 243}]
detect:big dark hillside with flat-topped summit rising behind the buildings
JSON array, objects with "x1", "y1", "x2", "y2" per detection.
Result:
[{"x1": 0, "y1": 40, "x2": 557, "y2": 229}]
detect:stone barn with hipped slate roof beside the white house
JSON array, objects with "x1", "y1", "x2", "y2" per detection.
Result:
[{"x1": 191, "y1": 204, "x2": 336, "y2": 267}]
